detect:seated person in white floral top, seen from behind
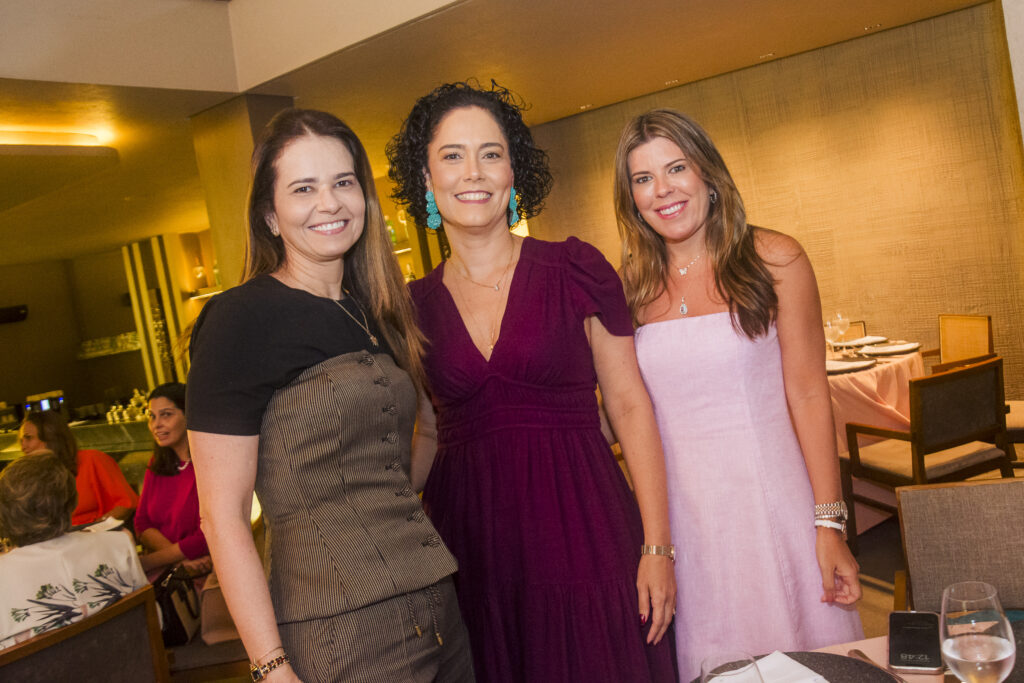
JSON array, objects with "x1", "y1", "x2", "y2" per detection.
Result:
[{"x1": 0, "y1": 453, "x2": 147, "y2": 649}]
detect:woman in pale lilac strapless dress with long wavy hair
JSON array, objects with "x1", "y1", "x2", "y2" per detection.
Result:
[{"x1": 614, "y1": 110, "x2": 861, "y2": 680}]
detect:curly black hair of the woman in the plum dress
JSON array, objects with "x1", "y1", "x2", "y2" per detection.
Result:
[{"x1": 386, "y1": 81, "x2": 552, "y2": 227}]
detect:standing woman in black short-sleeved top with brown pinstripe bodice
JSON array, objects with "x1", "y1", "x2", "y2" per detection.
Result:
[{"x1": 188, "y1": 110, "x2": 472, "y2": 683}]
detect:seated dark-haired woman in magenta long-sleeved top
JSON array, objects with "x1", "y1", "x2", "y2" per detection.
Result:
[{"x1": 135, "y1": 382, "x2": 212, "y2": 580}]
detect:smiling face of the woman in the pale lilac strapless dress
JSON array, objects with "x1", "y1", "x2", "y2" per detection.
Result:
[{"x1": 628, "y1": 137, "x2": 711, "y2": 245}]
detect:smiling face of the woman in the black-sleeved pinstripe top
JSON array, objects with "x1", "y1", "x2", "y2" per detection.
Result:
[{"x1": 267, "y1": 135, "x2": 366, "y2": 276}]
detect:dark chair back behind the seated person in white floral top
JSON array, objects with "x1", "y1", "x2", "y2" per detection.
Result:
[{"x1": 0, "y1": 586, "x2": 170, "y2": 683}]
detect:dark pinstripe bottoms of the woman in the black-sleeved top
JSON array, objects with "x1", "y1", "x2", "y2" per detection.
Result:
[{"x1": 279, "y1": 577, "x2": 474, "y2": 683}]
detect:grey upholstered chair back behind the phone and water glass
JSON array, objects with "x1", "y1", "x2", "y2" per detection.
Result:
[{"x1": 894, "y1": 479, "x2": 1024, "y2": 611}]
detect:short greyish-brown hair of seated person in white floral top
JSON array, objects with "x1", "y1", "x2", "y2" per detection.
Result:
[{"x1": 0, "y1": 451, "x2": 78, "y2": 548}]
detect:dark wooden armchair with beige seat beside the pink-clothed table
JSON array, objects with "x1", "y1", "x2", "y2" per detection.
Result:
[{"x1": 842, "y1": 356, "x2": 1013, "y2": 537}]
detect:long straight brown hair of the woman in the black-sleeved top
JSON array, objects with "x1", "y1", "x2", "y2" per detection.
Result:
[{"x1": 243, "y1": 109, "x2": 425, "y2": 390}]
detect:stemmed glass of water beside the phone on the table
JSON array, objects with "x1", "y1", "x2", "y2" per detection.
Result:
[{"x1": 939, "y1": 581, "x2": 1017, "y2": 683}]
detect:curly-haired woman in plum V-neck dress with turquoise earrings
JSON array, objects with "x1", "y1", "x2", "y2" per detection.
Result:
[{"x1": 387, "y1": 83, "x2": 676, "y2": 682}]
